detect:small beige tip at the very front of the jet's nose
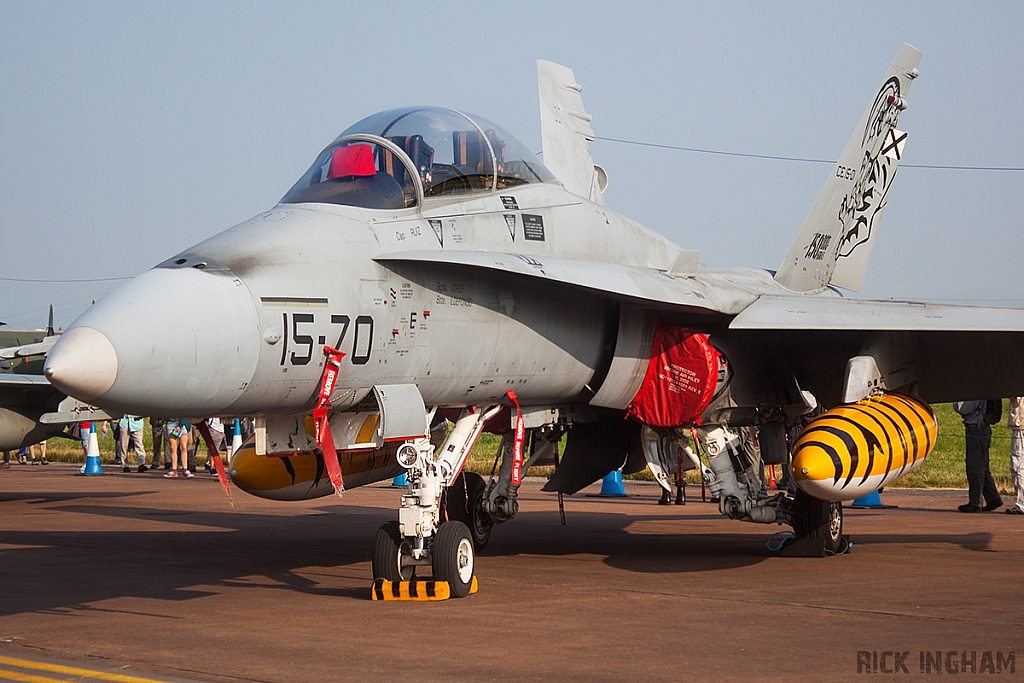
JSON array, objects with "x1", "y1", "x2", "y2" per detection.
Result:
[{"x1": 43, "y1": 327, "x2": 118, "y2": 401}]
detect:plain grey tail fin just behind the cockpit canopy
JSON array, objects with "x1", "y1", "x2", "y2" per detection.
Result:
[{"x1": 537, "y1": 59, "x2": 607, "y2": 205}]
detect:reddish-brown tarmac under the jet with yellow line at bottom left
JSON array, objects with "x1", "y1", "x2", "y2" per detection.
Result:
[{"x1": 0, "y1": 464, "x2": 1024, "y2": 682}]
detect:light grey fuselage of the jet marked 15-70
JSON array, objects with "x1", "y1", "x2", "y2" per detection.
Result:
[{"x1": 50, "y1": 183, "x2": 798, "y2": 417}]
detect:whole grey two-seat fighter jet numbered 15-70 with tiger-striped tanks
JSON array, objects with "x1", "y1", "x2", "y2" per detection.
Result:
[{"x1": 36, "y1": 45, "x2": 1024, "y2": 596}]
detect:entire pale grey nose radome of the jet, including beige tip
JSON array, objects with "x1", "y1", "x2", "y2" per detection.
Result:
[{"x1": 43, "y1": 267, "x2": 259, "y2": 418}]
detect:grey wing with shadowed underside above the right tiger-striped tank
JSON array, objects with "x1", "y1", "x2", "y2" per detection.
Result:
[{"x1": 729, "y1": 296, "x2": 1024, "y2": 403}]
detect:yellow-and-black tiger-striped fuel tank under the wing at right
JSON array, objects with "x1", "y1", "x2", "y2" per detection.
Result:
[{"x1": 793, "y1": 393, "x2": 938, "y2": 501}]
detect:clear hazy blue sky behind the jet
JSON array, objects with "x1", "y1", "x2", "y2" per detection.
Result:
[{"x1": 0, "y1": 0, "x2": 1024, "y2": 328}]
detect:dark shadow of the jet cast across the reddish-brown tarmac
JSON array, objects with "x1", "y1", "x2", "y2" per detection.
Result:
[{"x1": 0, "y1": 494, "x2": 990, "y2": 615}]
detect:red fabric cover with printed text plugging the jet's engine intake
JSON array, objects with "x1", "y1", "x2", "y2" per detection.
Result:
[{"x1": 626, "y1": 321, "x2": 718, "y2": 427}]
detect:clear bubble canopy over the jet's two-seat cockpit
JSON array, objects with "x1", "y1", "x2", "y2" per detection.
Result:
[{"x1": 282, "y1": 106, "x2": 555, "y2": 209}]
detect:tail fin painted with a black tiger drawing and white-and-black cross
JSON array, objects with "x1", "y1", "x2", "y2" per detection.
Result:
[{"x1": 775, "y1": 43, "x2": 921, "y2": 292}]
